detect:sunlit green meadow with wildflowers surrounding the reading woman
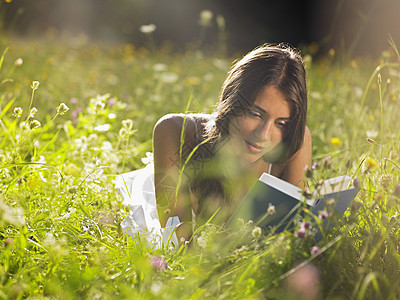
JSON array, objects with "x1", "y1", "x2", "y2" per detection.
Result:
[{"x1": 0, "y1": 36, "x2": 400, "y2": 299}]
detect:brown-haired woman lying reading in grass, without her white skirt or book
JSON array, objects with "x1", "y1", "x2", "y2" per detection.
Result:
[{"x1": 153, "y1": 45, "x2": 311, "y2": 238}]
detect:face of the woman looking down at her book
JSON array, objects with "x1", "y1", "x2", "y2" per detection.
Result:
[{"x1": 229, "y1": 85, "x2": 290, "y2": 163}]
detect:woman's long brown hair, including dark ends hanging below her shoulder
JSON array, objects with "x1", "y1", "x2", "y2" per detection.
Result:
[{"x1": 191, "y1": 44, "x2": 307, "y2": 217}]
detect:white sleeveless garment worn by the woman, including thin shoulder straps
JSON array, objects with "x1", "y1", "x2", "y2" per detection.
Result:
[{"x1": 115, "y1": 116, "x2": 272, "y2": 249}]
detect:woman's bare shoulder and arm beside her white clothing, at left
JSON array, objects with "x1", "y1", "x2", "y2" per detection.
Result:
[{"x1": 153, "y1": 114, "x2": 193, "y2": 239}]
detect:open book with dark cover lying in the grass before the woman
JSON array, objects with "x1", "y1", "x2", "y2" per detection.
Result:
[{"x1": 226, "y1": 173, "x2": 358, "y2": 237}]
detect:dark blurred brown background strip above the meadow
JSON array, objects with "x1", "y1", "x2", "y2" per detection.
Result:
[{"x1": 2, "y1": 0, "x2": 400, "y2": 55}]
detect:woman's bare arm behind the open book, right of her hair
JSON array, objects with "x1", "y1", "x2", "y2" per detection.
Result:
[{"x1": 282, "y1": 127, "x2": 312, "y2": 189}]
